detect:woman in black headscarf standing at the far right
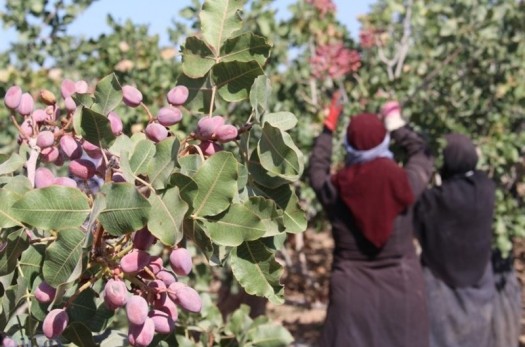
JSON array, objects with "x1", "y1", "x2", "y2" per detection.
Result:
[{"x1": 414, "y1": 134, "x2": 495, "y2": 347}]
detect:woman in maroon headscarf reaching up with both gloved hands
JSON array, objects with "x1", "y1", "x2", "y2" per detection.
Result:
[{"x1": 309, "y1": 100, "x2": 433, "y2": 347}]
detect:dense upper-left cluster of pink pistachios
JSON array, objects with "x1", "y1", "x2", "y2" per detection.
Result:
[{"x1": 4, "y1": 79, "x2": 105, "y2": 188}]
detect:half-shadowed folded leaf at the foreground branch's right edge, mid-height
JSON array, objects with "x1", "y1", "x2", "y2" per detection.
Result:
[{"x1": 252, "y1": 185, "x2": 307, "y2": 233}]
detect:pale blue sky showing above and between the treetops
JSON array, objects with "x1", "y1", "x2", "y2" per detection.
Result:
[{"x1": 0, "y1": 0, "x2": 374, "y2": 50}]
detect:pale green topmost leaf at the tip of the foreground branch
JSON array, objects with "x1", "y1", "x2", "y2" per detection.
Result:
[{"x1": 200, "y1": 0, "x2": 244, "y2": 54}]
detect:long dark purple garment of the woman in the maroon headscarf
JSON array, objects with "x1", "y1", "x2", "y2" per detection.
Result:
[{"x1": 309, "y1": 127, "x2": 433, "y2": 347}]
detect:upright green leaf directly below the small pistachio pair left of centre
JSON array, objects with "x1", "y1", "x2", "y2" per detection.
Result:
[{"x1": 147, "y1": 137, "x2": 180, "y2": 189}]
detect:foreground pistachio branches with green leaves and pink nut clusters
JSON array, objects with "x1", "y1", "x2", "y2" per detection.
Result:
[{"x1": 0, "y1": 0, "x2": 306, "y2": 346}]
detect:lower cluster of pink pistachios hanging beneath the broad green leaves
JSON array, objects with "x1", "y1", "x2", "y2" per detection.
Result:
[{"x1": 104, "y1": 229, "x2": 202, "y2": 346}]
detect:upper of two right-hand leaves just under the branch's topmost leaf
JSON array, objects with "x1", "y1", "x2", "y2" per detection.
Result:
[{"x1": 220, "y1": 32, "x2": 272, "y2": 66}]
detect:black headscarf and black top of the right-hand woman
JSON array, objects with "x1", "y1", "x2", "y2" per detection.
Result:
[{"x1": 414, "y1": 134, "x2": 495, "y2": 287}]
